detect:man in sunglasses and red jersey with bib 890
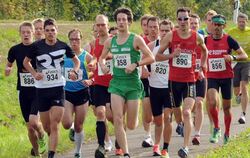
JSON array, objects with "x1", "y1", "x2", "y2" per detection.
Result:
[{"x1": 156, "y1": 7, "x2": 207, "y2": 157}]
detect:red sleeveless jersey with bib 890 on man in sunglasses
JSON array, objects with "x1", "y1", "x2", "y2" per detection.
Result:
[{"x1": 169, "y1": 30, "x2": 197, "y2": 82}]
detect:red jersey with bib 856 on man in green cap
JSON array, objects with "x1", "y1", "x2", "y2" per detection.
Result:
[{"x1": 206, "y1": 34, "x2": 234, "y2": 79}]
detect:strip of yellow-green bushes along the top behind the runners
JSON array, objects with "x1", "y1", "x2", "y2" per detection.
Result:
[{"x1": 0, "y1": 0, "x2": 250, "y2": 21}]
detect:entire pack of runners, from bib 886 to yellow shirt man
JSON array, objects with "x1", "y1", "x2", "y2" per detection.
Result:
[{"x1": 5, "y1": 7, "x2": 250, "y2": 158}]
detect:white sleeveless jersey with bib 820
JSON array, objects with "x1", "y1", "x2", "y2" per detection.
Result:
[{"x1": 148, "y1": 39, "x2": 169, "y2": 88}]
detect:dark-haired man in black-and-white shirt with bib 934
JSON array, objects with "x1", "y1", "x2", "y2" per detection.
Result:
[{"x1": 23, "y1": 19, "x2": 80, "y2": 158}]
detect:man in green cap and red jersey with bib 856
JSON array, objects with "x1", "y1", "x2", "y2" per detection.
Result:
[{"x1": 205, "y1": 14, "x2": 247, "y2": 144}]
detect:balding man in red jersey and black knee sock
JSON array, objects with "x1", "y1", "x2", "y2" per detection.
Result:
[{"x1": 88, "y1": 15, "x2": 112, "y2": 158}]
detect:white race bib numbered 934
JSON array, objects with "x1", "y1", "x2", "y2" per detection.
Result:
[{"x1": 42, "y1": 69, "x2": 62, "y2": 85}]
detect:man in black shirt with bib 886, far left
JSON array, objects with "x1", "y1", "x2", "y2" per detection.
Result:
[{"x1": 5, "y1": 22, "x2": 46, "y2": 156}]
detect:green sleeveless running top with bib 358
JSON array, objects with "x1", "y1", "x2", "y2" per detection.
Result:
[{"x1": 110, "y1": 33, "x2": 141, "y2": 80}]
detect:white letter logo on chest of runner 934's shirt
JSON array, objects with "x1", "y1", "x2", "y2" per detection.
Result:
[{"x1": 37, "y1": 49, "x2": 66, "y2": 69}]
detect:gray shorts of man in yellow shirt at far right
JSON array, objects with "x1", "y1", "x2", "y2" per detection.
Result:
[{"x1": 233, "y1": 62, "x2": 250, "y2": 87}]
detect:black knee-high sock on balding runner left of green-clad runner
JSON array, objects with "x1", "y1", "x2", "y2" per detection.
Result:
[{"x1": 96, "y1": 121, "x2": 106, "y2": 147}]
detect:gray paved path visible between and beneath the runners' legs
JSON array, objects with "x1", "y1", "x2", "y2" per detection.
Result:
[{"x1": 61, "y1": 107, "x2": 250, "y2": 158}]
